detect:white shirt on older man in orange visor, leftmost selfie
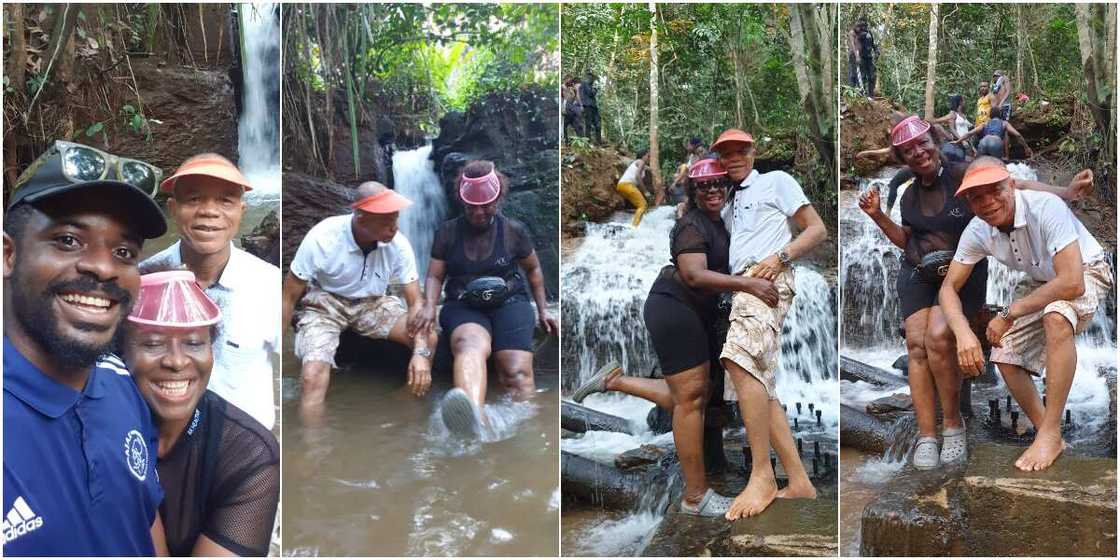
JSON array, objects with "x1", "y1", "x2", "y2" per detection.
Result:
[{"x1": 140, "y1": 241, "x2": 282, "y2": 430}]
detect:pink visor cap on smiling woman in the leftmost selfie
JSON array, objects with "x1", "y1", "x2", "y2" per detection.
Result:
[{"x1": 129, "y1": 270, "x2": 222, "y2": 328}]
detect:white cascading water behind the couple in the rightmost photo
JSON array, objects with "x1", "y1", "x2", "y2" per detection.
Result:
[{"x1": 839, "y1": 164, "x2": 1116, "y2": 435}]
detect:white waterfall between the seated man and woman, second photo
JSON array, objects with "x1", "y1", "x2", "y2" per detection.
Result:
[{"x1": 393, "y1": 144, "x2": 447, "y2": 277}]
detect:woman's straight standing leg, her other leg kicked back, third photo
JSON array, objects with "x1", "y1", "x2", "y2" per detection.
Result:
[{"x1": 665, "y1": 362, "x2": 708, "y2": 506}]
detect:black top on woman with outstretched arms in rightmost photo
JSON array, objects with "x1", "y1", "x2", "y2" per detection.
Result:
[{"x1": 888, "y1": 158, "x2": 973, "y2": 267}]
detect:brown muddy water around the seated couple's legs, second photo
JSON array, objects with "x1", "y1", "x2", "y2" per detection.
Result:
[{"x1": 282, "y1": 337, "x2": 560, "y2": 557}]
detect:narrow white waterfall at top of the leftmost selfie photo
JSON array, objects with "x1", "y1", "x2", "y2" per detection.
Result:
[{"x1": 237, "y1": 2, "x2": 281, "y2": 198}]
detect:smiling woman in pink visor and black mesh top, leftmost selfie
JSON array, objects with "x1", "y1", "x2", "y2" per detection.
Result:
[{"x1": 122, "y1": 270, "x2": 280, "y2": 557}]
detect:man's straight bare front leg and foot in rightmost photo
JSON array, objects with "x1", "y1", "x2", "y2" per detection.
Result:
[{"x1": 1015, "y1": 312, "x2": 1077, "y2": 470}]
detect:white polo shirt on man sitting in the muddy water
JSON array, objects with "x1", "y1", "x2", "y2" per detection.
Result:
[{"x1": 290, "y1": 214, "x2": 420, "y2": 299}]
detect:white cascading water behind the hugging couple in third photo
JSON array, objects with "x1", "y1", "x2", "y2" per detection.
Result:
[{"x1": 561, "y1": 206, "x2": 839, "y2": 556}]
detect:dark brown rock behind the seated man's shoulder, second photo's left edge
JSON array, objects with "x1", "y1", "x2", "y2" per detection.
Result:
[{"x1": 280, "y1": 172, "x2": 354, "y2": 272}]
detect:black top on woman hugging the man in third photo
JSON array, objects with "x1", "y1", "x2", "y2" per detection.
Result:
[{"x1": 650, "y1": 208, "x2": 731, "y2": 321}]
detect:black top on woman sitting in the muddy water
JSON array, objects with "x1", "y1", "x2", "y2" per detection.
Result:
[{"x1": 431, "y1": 213, "x2": 533, "y2": 301}]
